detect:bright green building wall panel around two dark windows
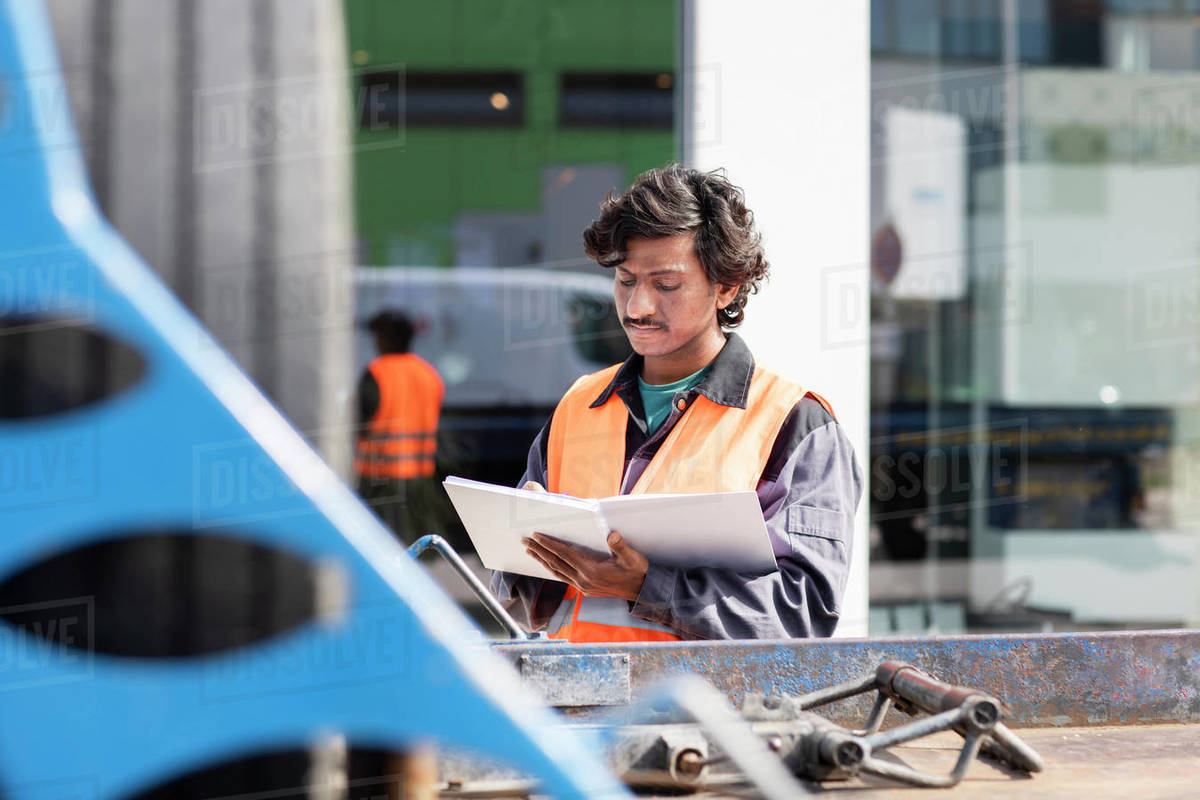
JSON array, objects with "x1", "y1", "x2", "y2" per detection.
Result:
[{"x1": 346, "y1": 0, "x2": 677, "y2": 266}]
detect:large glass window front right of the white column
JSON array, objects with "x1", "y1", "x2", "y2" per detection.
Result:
[{"x1": 870, "y1": 0, "x2": 1200, "y2": 633}]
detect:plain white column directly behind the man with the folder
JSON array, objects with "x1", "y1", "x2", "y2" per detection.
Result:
[{"x1": 680, "y1": 0, "x2": 870, "y2": 636}]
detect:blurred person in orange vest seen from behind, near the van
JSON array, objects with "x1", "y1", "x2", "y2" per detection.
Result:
[{"x1": 354, "y1": 311, "x2": 445, "y2": 545}]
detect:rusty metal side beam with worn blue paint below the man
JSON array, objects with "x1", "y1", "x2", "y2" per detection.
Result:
[{"x1": 496, "y1": 631, "x2": 1200, "y2": 728}]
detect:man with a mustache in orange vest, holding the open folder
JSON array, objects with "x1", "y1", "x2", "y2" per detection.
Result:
[{"x1": 492, "y1": 166, "x2": 863, "y2": 642}]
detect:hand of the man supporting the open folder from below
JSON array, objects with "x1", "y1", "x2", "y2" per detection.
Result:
[{"x1": 522, "y1": 530, "x2": 650, "y2": 601}]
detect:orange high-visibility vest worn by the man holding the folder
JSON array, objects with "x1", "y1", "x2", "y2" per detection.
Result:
[{"x1": 546, "y1": 365, "x2": 832, "y2": 642}]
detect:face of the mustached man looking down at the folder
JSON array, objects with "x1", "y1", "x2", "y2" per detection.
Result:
[{"x1": 613, "y1": 234, "x2": 737, "y2": 357}]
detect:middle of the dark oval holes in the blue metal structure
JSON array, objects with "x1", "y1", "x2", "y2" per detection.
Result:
[{"x1": 0, "y1": 530, "x2": 317, "y2": 658}]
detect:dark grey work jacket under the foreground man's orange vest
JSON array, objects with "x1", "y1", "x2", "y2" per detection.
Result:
[{"x1": 492, "y1": 333, "x2": 863, "y2": 639}]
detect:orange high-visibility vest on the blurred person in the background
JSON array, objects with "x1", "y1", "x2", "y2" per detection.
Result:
[{"x1": 354, "y1": 353, "x2": 445, "y2": 479}]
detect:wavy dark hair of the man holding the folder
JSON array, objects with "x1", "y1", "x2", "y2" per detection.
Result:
[{"x1": 583, "y1": 164, "x2": 770, "y2": 327}]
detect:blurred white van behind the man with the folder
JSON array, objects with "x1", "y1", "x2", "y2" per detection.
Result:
[{"x1": 355, "y1": 266, "x2": 630, "y2": 482}]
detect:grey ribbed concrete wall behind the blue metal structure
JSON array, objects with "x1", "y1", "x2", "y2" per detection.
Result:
[{"x1": 48, "y1": 0, "x2": 355, "y2": 468}]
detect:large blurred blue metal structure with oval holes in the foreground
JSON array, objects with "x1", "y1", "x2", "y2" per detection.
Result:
[{"x1": 0, "y1": 0, "x2": 625, "y2": 799}]
